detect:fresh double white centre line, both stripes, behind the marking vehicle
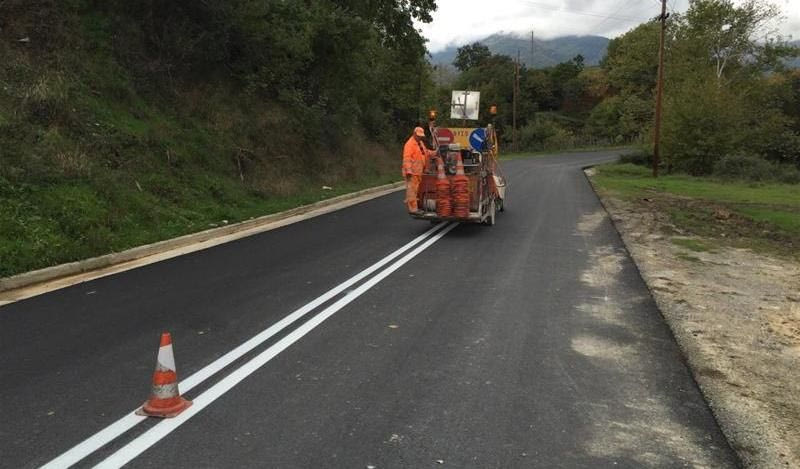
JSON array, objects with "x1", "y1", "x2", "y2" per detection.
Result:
[{"x1": 42, "y1": 223, "x2": 458, "y2": 469}]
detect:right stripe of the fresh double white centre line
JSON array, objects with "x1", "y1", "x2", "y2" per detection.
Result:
[{"x1": 94, "y1": 223, "x2": 458, "y2": 469}]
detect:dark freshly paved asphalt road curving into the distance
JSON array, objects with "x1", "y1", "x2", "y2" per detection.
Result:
[{"x1": 0, "y1": 153, "x2": 738, "y2": 468}]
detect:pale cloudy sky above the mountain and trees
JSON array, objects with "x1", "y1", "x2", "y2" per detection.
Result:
[{"x1": 420, "y1": 0, "x2": 800, "y2": 52}]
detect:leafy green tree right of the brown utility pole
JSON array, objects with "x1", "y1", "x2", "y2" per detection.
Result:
[{"x1": 663, "y1": 0, "x2": 797, "y2": 174}]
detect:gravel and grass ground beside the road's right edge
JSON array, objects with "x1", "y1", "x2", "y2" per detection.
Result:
[{"x1": 587, "y1": 165, "x2": 800, "y2": 468}]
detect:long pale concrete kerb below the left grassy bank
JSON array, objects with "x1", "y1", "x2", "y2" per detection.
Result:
[{"x1": 0, "y1": 182, "x2": 404, "y2": 292}]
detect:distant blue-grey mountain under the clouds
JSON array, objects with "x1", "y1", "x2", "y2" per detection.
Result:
[{"x1": 432, "y1": 33, "x2": 609, "y2": 68}]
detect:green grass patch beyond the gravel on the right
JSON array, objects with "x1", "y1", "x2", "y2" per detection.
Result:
[{"x1": 592, "y1": 164, "x2": 800, "y2": 258}]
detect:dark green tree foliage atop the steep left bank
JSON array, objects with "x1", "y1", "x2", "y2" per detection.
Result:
[{"x1": 85, "y1": 0, "x2": 435, "y2": 141}]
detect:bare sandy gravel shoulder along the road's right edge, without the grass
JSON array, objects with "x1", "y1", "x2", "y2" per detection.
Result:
[{"x1": 587, "y1": 169, "x2": 800, "y2": 468}]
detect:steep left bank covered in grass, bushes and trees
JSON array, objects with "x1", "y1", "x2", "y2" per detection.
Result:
[{"x1": 0, "y1": 0, "x2": 410, "y2": 278}]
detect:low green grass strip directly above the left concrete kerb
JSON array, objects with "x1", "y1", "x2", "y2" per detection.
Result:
[{"x1": 0, "y1": 178, "x2": 394, "y2": 277}]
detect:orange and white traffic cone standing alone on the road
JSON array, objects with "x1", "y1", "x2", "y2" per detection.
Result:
[{"x1": 136, "y1": 332, "x2": 192, "y2": 418}]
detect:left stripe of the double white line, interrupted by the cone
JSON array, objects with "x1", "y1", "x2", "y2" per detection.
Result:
[{"x1": 42, "y1": 223, "x2": 447, "y2": 469}]
